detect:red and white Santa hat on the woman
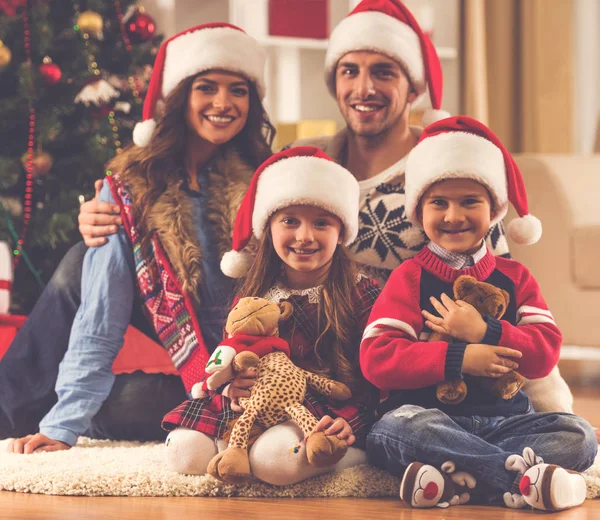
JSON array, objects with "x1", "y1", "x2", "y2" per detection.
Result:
[{"x1": 133, "y1": 23, "x2": 266, "y2": 146}]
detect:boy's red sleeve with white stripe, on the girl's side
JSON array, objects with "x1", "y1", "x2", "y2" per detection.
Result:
[{"x1": 360, "y1": 260, "x2": 448, "y2": 391}]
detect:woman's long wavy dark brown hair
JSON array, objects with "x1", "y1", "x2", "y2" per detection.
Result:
[{"x1": 107, "y1": 72, "x2": 275, "y2": 247}]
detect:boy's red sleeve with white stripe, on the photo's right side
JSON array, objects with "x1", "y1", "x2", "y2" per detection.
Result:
[{"x1": 499, "y1": 262, "x2": 562, "y2": 379}]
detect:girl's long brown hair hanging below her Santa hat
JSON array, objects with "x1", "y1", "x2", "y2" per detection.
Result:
[{"x1": 238, "y1": 226, "x2": 360, "y2": 388}]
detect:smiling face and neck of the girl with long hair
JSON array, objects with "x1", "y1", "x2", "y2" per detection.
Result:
[{"x1": 269, "y1": 205, "x2": 342, "y2": 289}]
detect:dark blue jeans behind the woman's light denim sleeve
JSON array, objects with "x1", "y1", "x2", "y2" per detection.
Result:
[{"x1": 0, "y1": 242, "x2": 186, "y2": 440}]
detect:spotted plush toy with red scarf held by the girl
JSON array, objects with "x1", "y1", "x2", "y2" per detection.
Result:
[{"x1": 202, "y1": 298, "x2": 351, "y2": 482}]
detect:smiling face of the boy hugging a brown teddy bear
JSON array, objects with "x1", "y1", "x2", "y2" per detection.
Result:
[{"x1": 418, "y1": 179, "x2": 492, "y2": 254}]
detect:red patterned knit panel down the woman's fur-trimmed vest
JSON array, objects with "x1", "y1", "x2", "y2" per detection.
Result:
[{"x1": 108, "y1": 177, "x2": 210, "y2": 392}]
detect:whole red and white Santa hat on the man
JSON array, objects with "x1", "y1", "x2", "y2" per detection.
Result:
[{"x1": 325, "y1": 0, "x2": 450, "y2": 126}]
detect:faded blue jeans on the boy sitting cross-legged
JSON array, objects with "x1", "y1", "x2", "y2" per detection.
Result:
[{"x1": 367, "y1": 405, "x2": 598, "y2": 502}]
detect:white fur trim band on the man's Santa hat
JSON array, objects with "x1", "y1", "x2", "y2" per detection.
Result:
[{"x1": 325, "y1": 11, "x2": 426, "y2": 95}]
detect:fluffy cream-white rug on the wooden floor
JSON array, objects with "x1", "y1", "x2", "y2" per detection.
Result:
[{"x1": 0, "y1": 439, "x2": 600, "y2": 498}]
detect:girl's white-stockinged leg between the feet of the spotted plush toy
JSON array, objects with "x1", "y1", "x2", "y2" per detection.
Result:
[{"x1": 250, "y1": 421, "x2": 367, "y2": 486}]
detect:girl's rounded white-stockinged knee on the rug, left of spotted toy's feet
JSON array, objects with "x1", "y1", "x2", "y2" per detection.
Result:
[{"x1": 165, "y1": 427, "x2": 218, "y2": 475}]
